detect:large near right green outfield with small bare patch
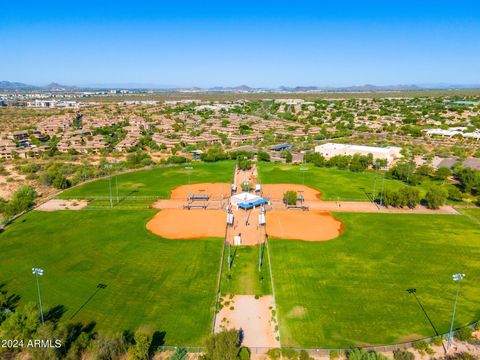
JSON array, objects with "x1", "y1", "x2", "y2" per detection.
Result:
[{"x1": 270, "y1": 213, "x2": 480, "y2": 348}]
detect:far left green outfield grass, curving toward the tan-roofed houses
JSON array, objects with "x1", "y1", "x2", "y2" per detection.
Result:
[{"x1": 59, "y1": 161, "x2": 235, "y2": 208}]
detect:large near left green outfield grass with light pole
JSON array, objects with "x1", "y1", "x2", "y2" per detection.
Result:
[{"x1": 0, "y1": 210, "x2": 222, "y2": 345}]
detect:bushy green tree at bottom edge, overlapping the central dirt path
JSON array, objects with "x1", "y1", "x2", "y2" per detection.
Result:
[{"x1": 204, "y1": 329, "x2": 240, "y2": 360}]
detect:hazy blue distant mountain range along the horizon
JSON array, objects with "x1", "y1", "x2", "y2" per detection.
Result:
[{"x1": 0, "y1": 81, "x2": 480, "y2": 93}]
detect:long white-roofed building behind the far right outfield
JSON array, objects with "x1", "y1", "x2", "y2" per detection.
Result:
[{"x1": 315, "y1": 143, "x2": 402, "y2": 165}]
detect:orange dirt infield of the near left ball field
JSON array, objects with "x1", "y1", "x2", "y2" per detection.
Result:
[{"x1": 147, "y1": 209, "x2": 226, "y2": 240}]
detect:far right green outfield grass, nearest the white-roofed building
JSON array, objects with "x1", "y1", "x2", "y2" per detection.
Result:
[{"x1": 258, "y1": 163, "x2": 424, "y2": 201}]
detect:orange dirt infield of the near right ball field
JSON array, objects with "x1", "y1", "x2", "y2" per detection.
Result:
[{"x1": 267, "y1": 210, "x2": 343, "y2": 241}]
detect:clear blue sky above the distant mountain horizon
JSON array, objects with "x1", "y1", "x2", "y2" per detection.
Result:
[{"x1": 0, "y1": 0, "x2": 480, "y2": 87}]
